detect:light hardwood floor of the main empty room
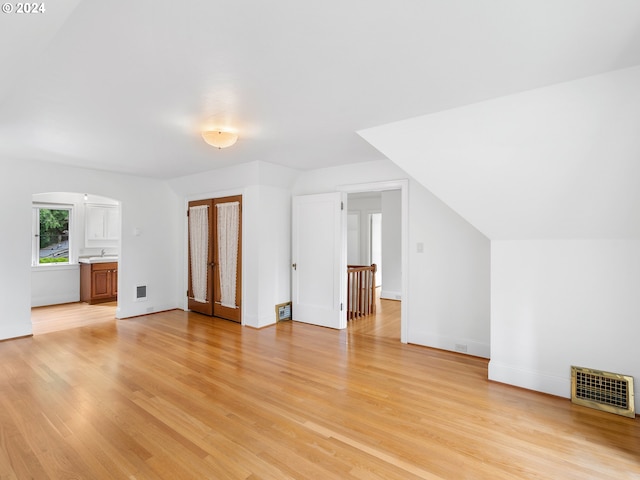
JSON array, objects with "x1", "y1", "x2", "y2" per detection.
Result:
[{"x1": 0, "y1": 310, "x2": 640, "y2": 480}]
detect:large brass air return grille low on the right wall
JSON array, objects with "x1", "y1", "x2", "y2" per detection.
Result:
[{"x1": 571, "y1": 367, "x2": 636, "y2": 418}]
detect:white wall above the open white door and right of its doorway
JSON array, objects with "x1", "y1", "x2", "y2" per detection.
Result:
[{"x1": 293, "y1": 161, "x2": 490, "y2": 357}]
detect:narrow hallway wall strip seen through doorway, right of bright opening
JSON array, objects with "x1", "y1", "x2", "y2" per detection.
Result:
[{"x1": 380, "y1": 190, "x2": 402, "y2": 300}]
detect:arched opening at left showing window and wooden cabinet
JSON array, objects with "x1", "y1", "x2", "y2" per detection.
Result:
[{"x1": 31, "y1": 192, "x2": 121, "y2": 334}]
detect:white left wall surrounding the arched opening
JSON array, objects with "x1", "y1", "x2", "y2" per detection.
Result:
[{"x1": 0, "y1": 158, "x2": 179, "y2": 339}]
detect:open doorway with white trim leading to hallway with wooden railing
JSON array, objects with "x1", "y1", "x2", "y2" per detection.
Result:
[{"x1": 343, "y1": 180, "x2": 408, "y2": 342}]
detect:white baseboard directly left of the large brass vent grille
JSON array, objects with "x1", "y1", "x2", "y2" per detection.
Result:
[{"x1": 489, "y1": 360, "x2": 571, "y2": 398}]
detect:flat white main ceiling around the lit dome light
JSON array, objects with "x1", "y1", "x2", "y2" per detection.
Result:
[{"x1": 0, "y1": 0, "x2": 640, "y2": 180}]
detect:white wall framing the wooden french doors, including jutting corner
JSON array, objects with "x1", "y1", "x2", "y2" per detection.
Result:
[{"x1": 169, "y1": 162, "x2": 297, "y2": 328}]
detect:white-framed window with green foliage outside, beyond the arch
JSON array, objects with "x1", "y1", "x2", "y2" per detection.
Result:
[{"x1": 32, "y1": 204, "x2": 72, "y2": 265}]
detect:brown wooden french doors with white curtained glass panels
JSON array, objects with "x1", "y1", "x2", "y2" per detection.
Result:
[{"x1": 187, "y1": 195, "x2": 242, "y2": 322}]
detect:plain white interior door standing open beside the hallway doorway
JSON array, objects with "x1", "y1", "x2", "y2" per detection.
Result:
[{"x1": 292, "y1": 192, "x2": 347, "y2": 328}]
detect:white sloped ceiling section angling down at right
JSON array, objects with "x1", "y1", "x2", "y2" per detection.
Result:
[{"x1": 360, "y1": 67, "x2": 640, "y2": 239}]
